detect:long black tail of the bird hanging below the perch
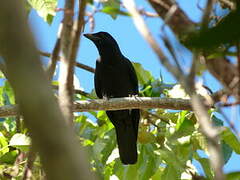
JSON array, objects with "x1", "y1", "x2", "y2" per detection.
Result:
[{"x1": 115, "y1": 121, "x2": 137, "y2": 164}]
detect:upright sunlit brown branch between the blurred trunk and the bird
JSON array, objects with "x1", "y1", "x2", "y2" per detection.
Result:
[{"x1": 59, "y1": 0, "x2": 74, "y2": 124}]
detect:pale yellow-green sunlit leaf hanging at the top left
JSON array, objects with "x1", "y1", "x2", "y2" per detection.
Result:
[{"x1": 28, "y1": 0, "x2": 57, "y2": 24}]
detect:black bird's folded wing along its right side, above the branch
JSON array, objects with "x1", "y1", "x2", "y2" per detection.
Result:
[{"x1": 124, "y1": 58, "x2": 138, "y2": 95}]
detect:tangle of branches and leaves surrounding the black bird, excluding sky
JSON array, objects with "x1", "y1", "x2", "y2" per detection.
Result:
[{"x1": 0, "y1": 0, "x2": 240, "y2": 180}]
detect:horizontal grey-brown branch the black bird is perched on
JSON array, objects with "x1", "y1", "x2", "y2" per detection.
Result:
[{"x1": 0, "y1": 97, "x2": 192, "y2": 117}]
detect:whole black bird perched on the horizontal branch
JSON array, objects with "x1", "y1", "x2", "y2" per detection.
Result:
[{"x1": 84, "y1": 32, "x2": 140, "y2": 164}]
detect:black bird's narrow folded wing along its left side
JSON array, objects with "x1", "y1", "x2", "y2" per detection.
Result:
[{"x1": 94, "y1": 60, "x2": 103, "y2": 99}]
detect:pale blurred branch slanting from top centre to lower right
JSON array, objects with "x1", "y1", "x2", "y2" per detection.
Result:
[{"x1": 123, "y1": 0, "x2": 224, "y2": 180}]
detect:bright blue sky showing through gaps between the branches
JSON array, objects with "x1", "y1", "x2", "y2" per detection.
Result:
[{"x1": 29, "y1": 0, "x2": 240, "y2": 175}]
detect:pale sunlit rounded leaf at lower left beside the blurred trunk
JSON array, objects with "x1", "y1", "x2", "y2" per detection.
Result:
[{"x1": 9, "y1": 133, "x2": 31, "y2": 152}]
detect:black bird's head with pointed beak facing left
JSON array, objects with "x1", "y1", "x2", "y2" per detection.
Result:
[{"x1": 84, "y1": 32, "x2": 121, "y2": 56}]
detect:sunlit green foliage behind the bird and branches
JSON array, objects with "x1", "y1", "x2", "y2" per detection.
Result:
[{"x1": 0, "y1": 0, "x2": 240, "y2": 180}]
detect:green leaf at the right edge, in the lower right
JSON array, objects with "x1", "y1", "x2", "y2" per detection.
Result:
[{"x1": 221, "y1": 127, "x2": 240, "y2": 154}]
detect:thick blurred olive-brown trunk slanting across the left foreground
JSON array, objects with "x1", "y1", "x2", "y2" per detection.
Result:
[{"x1": 0, "y1": 1, "x2": 94, "y2": 180}]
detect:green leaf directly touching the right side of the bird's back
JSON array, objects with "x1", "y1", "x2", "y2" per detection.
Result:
[{"x1": 132, "y1": 63, "x2": 154, "y2": 85}]
